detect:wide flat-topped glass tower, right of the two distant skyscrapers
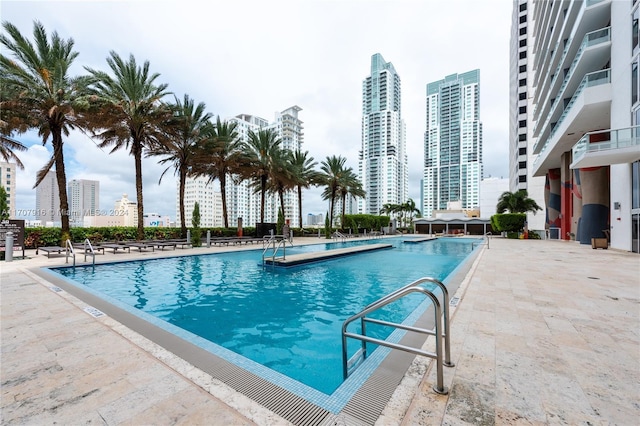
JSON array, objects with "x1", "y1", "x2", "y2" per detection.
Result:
[{"x1": 421, "y1": 70, "x2": 482, "y2": 217}]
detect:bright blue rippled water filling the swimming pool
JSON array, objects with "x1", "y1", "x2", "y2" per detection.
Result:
[{"x1": 52, "y1": 239, "x2": 477, "y2": 394}]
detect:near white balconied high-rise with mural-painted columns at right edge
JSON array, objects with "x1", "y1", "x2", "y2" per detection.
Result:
[{"x1": 528, "y1": 0, "x2": 640, "y2": 252}]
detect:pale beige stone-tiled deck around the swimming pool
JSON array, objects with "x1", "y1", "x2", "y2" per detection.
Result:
[{"x1": 0, "y1": 237, "x2": 640, "y2": 426}]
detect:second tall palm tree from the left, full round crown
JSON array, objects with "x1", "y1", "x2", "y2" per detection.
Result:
[{"x1": 85, "y1": 51, "x2": 172, "y2": 240}]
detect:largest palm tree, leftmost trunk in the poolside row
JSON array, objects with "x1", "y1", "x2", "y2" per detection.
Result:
[{"x1": 0, "y1": 21, "x2": 83, "y2": 238}]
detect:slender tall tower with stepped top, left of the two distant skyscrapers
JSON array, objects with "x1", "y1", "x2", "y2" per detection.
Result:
[{"x1": 358, "y1": 53, "x2": 409, "y2": 214}]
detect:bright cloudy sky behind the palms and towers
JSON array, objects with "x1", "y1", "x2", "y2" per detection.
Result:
[{"x1": 0, "y1": 0, "x2": 512, "y2": 218}]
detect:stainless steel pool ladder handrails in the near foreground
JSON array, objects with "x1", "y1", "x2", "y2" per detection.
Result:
[{"x1": 342, "y1": 277, "x2": 455, "y2": 395}]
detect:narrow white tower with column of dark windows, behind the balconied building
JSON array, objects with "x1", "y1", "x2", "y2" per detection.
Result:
[{"x1": 508, "y1": 0, "x2": 545, "y2": 234}]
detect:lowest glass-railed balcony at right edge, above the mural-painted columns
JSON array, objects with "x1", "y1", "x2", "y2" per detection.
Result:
[{"x1": 570, "y1": 126, "x2": 640, "y2": 169}]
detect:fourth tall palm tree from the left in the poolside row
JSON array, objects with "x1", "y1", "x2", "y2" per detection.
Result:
[{"x1": 192, "y1": 116, "x2": 243, "y2": 228}]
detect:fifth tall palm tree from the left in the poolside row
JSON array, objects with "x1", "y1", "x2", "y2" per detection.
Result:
[{"x1": 243, "y1": 129, "x2": 284, "y2": 223}]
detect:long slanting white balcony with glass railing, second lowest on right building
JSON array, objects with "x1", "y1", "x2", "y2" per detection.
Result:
[{"x1": 532, "y1": 69, "x2": 612, "y2": 176}]
